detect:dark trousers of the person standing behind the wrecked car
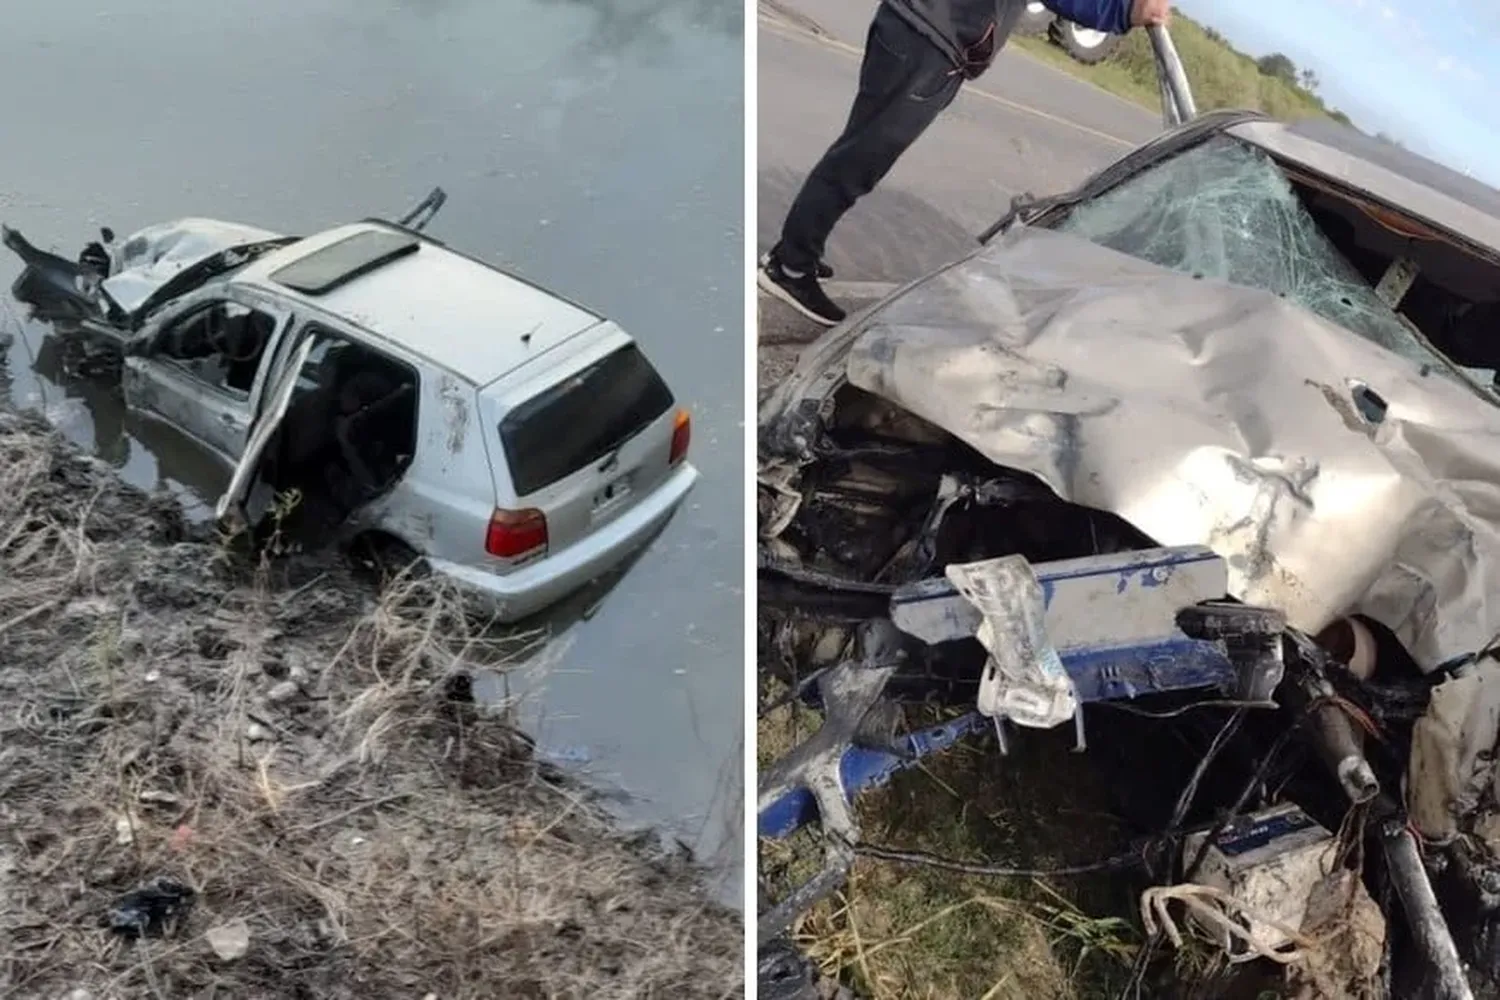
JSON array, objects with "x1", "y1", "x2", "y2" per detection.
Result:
[{"x1": 777, "y1": 4, "x2": 963, "y2": 271}]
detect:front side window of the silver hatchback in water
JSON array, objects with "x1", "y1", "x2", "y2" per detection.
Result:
[{"x1": 155, "y1": 300, "x2": 276, "y2": 399}]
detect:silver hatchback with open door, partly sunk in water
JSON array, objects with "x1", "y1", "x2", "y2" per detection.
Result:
[{"x1": 3, "y1": 189, "x2": 698, "y2": 621}]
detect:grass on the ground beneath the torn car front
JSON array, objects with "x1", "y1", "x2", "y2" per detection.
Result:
[{"x1": 758, "y1": 692, "x2": 1142, "y2": 1000}]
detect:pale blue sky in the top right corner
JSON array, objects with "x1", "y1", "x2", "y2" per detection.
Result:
[{"x1": 1176, "y1": 0, "x2": 1500, "y2": 187}]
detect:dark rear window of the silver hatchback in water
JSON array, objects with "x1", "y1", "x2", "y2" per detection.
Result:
[{"x1": 500, "y1": 345, "x2": 675, "y2": 496}]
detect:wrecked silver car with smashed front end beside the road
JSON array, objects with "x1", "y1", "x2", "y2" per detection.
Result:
[{"x1": 759, "y1": 70, "x2": 1500, "y2": 997}]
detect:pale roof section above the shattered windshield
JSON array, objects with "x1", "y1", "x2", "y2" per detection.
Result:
[{"x1": 1227, "y1": 118, "x2": 1500, "y2": 255}]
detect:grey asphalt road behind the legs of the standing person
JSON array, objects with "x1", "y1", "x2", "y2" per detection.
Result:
[{"x1": 756, "y1": 0, "x2": 1161, "y2": 335}]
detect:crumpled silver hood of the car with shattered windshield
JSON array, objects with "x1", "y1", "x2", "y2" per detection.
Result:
[{"x1": 828, "y1": 228, "x2": 1500, "y2": 669}]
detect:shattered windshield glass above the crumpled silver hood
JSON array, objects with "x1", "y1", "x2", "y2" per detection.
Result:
[{"x1": 1056, "y1": 135, "x2": 1463, "y2": 381}]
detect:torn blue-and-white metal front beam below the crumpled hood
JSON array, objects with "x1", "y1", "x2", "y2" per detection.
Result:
[{"x1": 758, "y1": 547, "x2": 1286, "y2": 837}]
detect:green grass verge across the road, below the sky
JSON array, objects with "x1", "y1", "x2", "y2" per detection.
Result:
[{"x1": 1011, "y1": 13, "x2": 1349, "y2": 123}]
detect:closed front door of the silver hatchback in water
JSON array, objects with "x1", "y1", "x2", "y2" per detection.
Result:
[{"x1": 123, "y1": 292, "x2": 291, "y2": 465}]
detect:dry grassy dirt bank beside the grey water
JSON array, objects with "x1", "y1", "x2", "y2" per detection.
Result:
[{"x1": 0, "y1": 414, "x2": 744, "y2": 1000}]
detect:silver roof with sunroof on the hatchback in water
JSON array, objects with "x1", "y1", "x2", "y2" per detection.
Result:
[{"x1": 233, "y1": 220, "x2": 603, "y2": 385}]
